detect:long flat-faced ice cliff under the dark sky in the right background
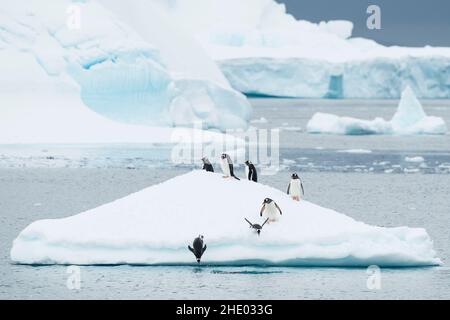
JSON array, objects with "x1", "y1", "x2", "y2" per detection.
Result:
[{"x1": 153, "y1": 0, "x2": 450, "y2": 99}]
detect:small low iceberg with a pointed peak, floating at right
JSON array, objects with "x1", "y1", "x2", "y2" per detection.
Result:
[{"x1": 307, "y1": 87, "x2": 448, "y2": 135}]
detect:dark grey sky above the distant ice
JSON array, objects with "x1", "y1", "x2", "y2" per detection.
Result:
[{"x1": 277, "y1": 0, "x2": 450, "y2": 47}]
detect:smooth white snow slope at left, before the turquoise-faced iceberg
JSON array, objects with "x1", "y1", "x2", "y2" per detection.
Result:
[{"x1": 0, "y1": 50, "x2": 241, "y2": 146}]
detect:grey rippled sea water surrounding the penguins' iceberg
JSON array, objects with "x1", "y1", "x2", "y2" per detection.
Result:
[{"x1": 0, "y1": 99, "x2": 450, "y2": 299}]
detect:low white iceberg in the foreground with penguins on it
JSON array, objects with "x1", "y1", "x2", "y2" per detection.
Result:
[{"x1": 11, "y1": 171, "x2": 441, "y2": 267}]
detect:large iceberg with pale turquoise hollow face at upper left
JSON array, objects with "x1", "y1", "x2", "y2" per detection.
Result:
[{"x1": 0, "y1": 0, "x2": 251, "y2": 139}]
